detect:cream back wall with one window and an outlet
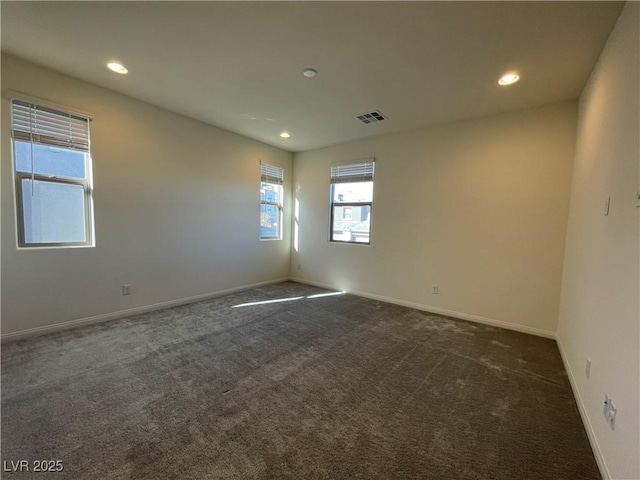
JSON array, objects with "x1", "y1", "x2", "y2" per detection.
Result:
[{"x1": 291, "y1": 102, "x2": 576, "y2": 337}]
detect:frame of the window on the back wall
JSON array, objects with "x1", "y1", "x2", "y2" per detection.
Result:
[{"x1": 329, "y1": 158, "x2": 375, "y2": 245}]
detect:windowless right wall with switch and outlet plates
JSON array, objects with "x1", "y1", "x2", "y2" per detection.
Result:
[{"x1": 558, "y1": 2, "x2": 640, "y2": 479}]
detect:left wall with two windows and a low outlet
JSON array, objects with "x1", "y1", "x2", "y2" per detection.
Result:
[{"x1": 2, "y1": 55, "x2": 292, "y2": 338}]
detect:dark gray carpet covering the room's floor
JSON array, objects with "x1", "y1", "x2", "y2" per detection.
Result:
[{"x1": 2, "y1": 282, "x2": 600, "y2": 480}]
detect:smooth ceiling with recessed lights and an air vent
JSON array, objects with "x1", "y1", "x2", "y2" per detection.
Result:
[{"x1": 1, "y1": 1, "x2": 623, "y2": 151}]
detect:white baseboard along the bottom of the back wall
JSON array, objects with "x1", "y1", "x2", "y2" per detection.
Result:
[{"x1": 290, "y1": 277, "x2": 556, "y2": 340}]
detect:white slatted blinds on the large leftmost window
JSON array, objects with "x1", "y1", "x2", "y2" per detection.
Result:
[{"x1": 11, "y1": 100, "x2": 89, "y2": 152}]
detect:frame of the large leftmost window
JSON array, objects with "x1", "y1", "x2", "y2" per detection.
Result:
[{"x1": 10, "y1": 96, "x2": 95, "y2": 250}]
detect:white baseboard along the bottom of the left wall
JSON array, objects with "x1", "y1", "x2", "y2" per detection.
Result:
[{"x1": 0, "y1": 277, "x2": 289, "y2": 343}]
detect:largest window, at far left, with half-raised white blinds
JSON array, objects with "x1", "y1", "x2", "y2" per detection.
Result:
[{"x1": 11, "y1": 100, "x2": 93, "y2": 247}]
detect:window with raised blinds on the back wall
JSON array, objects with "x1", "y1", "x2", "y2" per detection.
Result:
[{"x1": 329, "y1": 159, "x2": 375, "y2": 245}]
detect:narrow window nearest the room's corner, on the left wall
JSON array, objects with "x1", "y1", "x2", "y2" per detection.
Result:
[{"x1": 260, "y1": 163, "x2": 284, "y2": 240}]
